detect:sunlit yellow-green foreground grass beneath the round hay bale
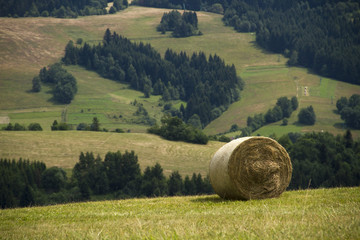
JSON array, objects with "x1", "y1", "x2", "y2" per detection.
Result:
[{"x1": 0, "y1": 187, "x2": 360, "y2": 239}]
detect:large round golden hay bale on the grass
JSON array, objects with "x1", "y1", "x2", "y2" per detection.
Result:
[{"x1": 210, "y1": 137, "x2": 292, "y2": 200}]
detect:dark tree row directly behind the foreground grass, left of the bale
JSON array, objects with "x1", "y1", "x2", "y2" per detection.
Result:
[{"x1": 0, "y1": 151, "x2": 213, "y2": 208}]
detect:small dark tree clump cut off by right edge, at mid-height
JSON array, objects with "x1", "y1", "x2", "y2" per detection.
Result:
[{"x1": 336, "y1": 94, "x2": 360, "y2": 129}]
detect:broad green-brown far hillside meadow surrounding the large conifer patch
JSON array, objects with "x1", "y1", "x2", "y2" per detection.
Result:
[{"x1": 0, "y1": 7, "x2": 360, "y2": 137}]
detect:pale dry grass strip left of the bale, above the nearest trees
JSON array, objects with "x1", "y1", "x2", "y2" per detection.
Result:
[{"x1": 0, "y1": 131, "x2": 223, "y2": 176}]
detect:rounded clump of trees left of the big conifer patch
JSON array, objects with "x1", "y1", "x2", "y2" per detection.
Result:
[{"x1": 32, "y1": 63, "x2": 77, "y2": 104}]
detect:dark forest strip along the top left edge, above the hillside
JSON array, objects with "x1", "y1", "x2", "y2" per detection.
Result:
[{"x1": 0, "y1": 0, "x2": 114, "y2": 18}]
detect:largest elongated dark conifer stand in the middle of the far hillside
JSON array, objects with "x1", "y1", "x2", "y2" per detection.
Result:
[{"x1": 63, "y1": 29, "x2": 243, "y2": 126}]
